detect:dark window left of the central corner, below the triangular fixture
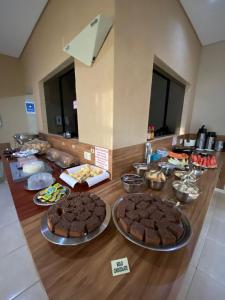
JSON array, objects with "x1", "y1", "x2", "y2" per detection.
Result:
[{"x1": 44, "y1": 64, "x2": 78, "y2": 137}]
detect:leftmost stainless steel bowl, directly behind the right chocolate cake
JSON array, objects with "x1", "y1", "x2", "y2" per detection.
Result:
[{"x1": 121, "y1": 174, "x2": 146, "y2": 193}]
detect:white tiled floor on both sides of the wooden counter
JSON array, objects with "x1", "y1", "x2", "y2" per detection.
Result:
[{"x1": 0, "y1": 182, "x2": 225, "y2": 300}]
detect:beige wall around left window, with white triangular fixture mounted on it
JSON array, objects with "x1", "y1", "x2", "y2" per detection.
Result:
[{"x1": 21, "y1": 0, "x2": 114, "y2": 148}]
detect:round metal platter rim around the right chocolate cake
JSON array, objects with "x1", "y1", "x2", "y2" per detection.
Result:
[{"x1": 112, "y1": 198, "x2": 192, "y2": 252}]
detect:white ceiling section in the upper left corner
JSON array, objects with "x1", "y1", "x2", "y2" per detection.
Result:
[{"x1": 0, "y1": 0, "x2": 48, "y2": 57}]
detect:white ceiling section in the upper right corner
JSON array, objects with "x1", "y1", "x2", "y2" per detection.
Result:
[{"x1": 180, "y1": 0, "x2": 225, "y2": 46}]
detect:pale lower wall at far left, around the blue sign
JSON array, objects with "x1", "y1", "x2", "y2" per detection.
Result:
[{"x1": 0, "y1": 95, "x2": 37, "y2": 146}]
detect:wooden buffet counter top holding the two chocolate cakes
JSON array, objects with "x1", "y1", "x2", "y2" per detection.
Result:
[{"x1": 2, "y1": 153, "x2": 225, "y2": 300}]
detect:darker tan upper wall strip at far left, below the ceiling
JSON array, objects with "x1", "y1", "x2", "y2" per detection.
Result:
[{"x1": 0, "y1": 54, "x2": 24, "y2": 96}]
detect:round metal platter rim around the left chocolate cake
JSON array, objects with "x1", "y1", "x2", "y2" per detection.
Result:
[{"x1": 41, "y1": 203, "x2": 111, "y2": 246}]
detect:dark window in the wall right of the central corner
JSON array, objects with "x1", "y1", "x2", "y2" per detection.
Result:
[{"x1": 149, "y1": 65, "x2": 185, "y2": 136}]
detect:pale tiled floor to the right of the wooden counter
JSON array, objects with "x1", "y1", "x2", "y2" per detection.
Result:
[{"x1": 177, "y1": 191, "x2": 225, "y2": 300}]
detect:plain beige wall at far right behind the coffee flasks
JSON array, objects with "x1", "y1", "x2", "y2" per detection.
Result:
[{"x1": 191, "y1": 41, "x2": 225, "y2": 135}]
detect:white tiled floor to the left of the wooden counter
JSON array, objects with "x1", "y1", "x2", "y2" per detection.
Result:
[{"x1": 0, "y1": 183, "x2": 48, "y2": 300}]
